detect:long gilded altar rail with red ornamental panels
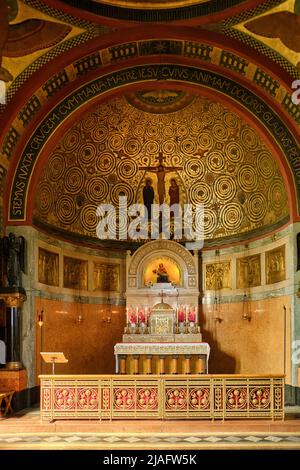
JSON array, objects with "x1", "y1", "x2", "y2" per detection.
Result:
[{"x1": 40, "y1": 375, "x2": 284, "y2": 421}]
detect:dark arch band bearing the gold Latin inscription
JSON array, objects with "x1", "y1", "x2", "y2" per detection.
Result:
[{"x1": 7, "y1": 63, "x2": 300, "y2": 223}]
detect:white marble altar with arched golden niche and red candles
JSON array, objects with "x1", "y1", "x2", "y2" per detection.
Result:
[{"x1": 114, "y1": 240, "x2": 210, "y2": 375}]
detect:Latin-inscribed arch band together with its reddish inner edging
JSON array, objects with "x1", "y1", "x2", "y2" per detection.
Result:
[{"x1": 6, "y1": 60, "x2": 300, "y2": 224}]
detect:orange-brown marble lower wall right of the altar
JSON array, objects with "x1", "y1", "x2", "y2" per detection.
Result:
[{"x1": 200, "y1": 296, "x2": 291, "y2": 383}]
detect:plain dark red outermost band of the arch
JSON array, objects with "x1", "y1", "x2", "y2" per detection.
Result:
[{"x1": 0, "y1": 25, "x2": 300, "y2": 151}]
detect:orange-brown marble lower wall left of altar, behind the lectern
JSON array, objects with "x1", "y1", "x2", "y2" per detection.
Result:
[{"x1": 35, "y1": 300, "x2": 125, "y2": 384}]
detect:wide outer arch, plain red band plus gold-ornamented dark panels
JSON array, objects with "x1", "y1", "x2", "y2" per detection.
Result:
[{"x1": 0, "y1": 25, "x2": 300, "y2": 168}]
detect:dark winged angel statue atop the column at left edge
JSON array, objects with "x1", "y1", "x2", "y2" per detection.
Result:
[{"x1": 2, "y1": 232, "x2": 25, "y2": 287}]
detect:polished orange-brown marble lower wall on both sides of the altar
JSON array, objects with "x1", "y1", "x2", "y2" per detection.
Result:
[{"x1": 36, "y1": 296, "x2": 291, "y2": 383}]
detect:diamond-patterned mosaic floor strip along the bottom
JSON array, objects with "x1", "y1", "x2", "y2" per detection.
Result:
[{"x1": 0, "y1": 433, "x2": 300, "y2": 449}]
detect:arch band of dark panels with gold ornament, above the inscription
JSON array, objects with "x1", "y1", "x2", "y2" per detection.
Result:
[{"x1": 0, "y1": 34, "x2": 300, "y2": 170}]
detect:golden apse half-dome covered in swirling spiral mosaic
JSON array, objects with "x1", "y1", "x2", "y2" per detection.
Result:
[{"x1": 34, "y1": 94, "x2": 289, "y2": 244}]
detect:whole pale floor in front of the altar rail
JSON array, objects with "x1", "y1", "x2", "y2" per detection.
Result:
[{"x1": 0, "y1": 407, "x2": 300, "y2": 450}]
